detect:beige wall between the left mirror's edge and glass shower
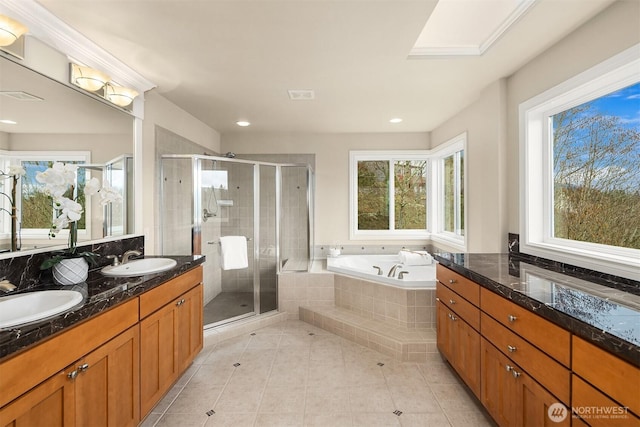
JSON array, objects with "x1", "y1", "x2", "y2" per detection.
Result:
[{"x1": 140, "y1": 91, "x2": 220, "y2": 254}]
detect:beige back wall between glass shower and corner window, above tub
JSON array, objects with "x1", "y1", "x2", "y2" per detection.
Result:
[{"x1": 221, "y1": 133, "x2": 429, "y2": 245}]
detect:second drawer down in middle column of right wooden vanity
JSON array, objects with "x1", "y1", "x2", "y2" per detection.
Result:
[{"x1": 480, "y1": 313, "x2": 571, "y2": 405}]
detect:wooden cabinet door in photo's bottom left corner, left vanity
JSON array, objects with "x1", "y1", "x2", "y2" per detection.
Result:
[{"x1": 0, "y1": 371, "x2": 75, "y2": 427}]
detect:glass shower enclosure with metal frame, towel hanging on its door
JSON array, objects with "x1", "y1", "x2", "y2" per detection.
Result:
[{"x1": 160, "y1": 154, "x2": 313, "y2": 328}]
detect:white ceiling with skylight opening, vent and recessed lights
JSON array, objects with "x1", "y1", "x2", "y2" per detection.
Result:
[{"x1": 39, "y1": 0, "x2": 613, "y2": 133}]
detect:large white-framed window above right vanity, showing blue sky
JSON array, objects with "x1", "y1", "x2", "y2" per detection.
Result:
[{"x1": 520, "y1": 48, "x2": 640, "y2": 280}]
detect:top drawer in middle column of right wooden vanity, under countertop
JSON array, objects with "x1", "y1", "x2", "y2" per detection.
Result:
[{"x1": 480, "y1": 288, "x2": 571, "y2": 367}]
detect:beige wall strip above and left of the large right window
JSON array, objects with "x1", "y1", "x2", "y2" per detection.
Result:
[{"x1": 507, "y1": 0, "x2": 640, "y2": 233}]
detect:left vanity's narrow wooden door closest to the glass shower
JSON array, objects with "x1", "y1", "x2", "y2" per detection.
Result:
[{"x1": 177, "y1": 285, "x2": 204, "y2": 372}]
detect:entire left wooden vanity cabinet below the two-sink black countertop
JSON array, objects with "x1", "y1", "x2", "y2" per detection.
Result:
[{"x1": 0, "y1": 266, "x2": 203, "y2": 427}]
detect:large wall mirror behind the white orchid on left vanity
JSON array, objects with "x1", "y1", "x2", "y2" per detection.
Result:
[{"x1": 0, "y1": 56, "x2": 134, "y2": 257}]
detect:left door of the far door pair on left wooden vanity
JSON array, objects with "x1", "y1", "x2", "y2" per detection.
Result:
[{"x1": 140, "y1": 303, "x2": 179, "y2": 418}]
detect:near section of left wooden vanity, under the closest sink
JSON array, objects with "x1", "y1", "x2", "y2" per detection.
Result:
[{"x1": 0, "y1": 298, "x2": 140, "y2": 427}]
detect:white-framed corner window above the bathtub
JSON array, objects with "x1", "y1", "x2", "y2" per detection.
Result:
[{"x1": 350, "y1": 134, "x2": 466, "y2": 246}]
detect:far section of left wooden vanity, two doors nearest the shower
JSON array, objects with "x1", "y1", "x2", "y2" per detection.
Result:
[{"x1": 140, "y1": 267, "x2": 203, "y2": 418}]
